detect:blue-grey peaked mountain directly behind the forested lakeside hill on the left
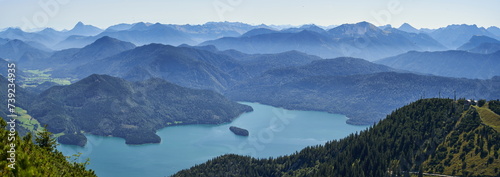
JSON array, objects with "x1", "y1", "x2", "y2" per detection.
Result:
[{"x1": 48, "y1": 37, "x2": 321, "y2": 92}]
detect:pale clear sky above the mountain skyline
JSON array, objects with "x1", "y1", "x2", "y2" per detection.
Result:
[{"x1": 0, "y1": 0, "x2": 500, "y2": 30}]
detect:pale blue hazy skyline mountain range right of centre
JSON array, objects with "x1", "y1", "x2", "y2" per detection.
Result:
[{"x1": 201, "y1": 22, "x2": 445, "y2": 60}]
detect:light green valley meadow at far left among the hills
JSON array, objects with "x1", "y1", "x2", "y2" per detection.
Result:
[{"x1": 21, "y1": 69, "x2": 74, "y2": 87}]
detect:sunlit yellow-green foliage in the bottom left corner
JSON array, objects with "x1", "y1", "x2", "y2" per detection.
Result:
[{"x1": 0, "y1": 119, "x2": 96, "y2": 177}]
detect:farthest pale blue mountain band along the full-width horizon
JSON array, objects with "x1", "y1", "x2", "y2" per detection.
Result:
[{"x1": 0, "y1": 22, "x2": 500, "y2": 60}]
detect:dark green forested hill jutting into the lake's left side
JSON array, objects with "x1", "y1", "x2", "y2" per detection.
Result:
[{"x1": 29, "y1": 75, "x2": 252, "y2": 144}]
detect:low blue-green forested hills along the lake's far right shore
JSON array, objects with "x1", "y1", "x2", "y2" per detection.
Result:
[{"x1": 225, "y1": 70, "x2": 500, "y2": 125}]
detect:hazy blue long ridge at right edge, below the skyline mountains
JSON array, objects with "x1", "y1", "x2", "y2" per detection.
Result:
[{"x1": 376, "y1": 50, "x2": 500, "y2": 79}]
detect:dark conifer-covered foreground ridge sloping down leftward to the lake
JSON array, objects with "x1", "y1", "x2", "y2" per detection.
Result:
[{"x1": 174, "y1": 99, "x2": 500, "y2": 177}]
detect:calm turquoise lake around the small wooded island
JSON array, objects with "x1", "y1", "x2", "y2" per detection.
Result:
[{"x1": 58, "y1": 102, "x2": 367, "y2": 177}]
